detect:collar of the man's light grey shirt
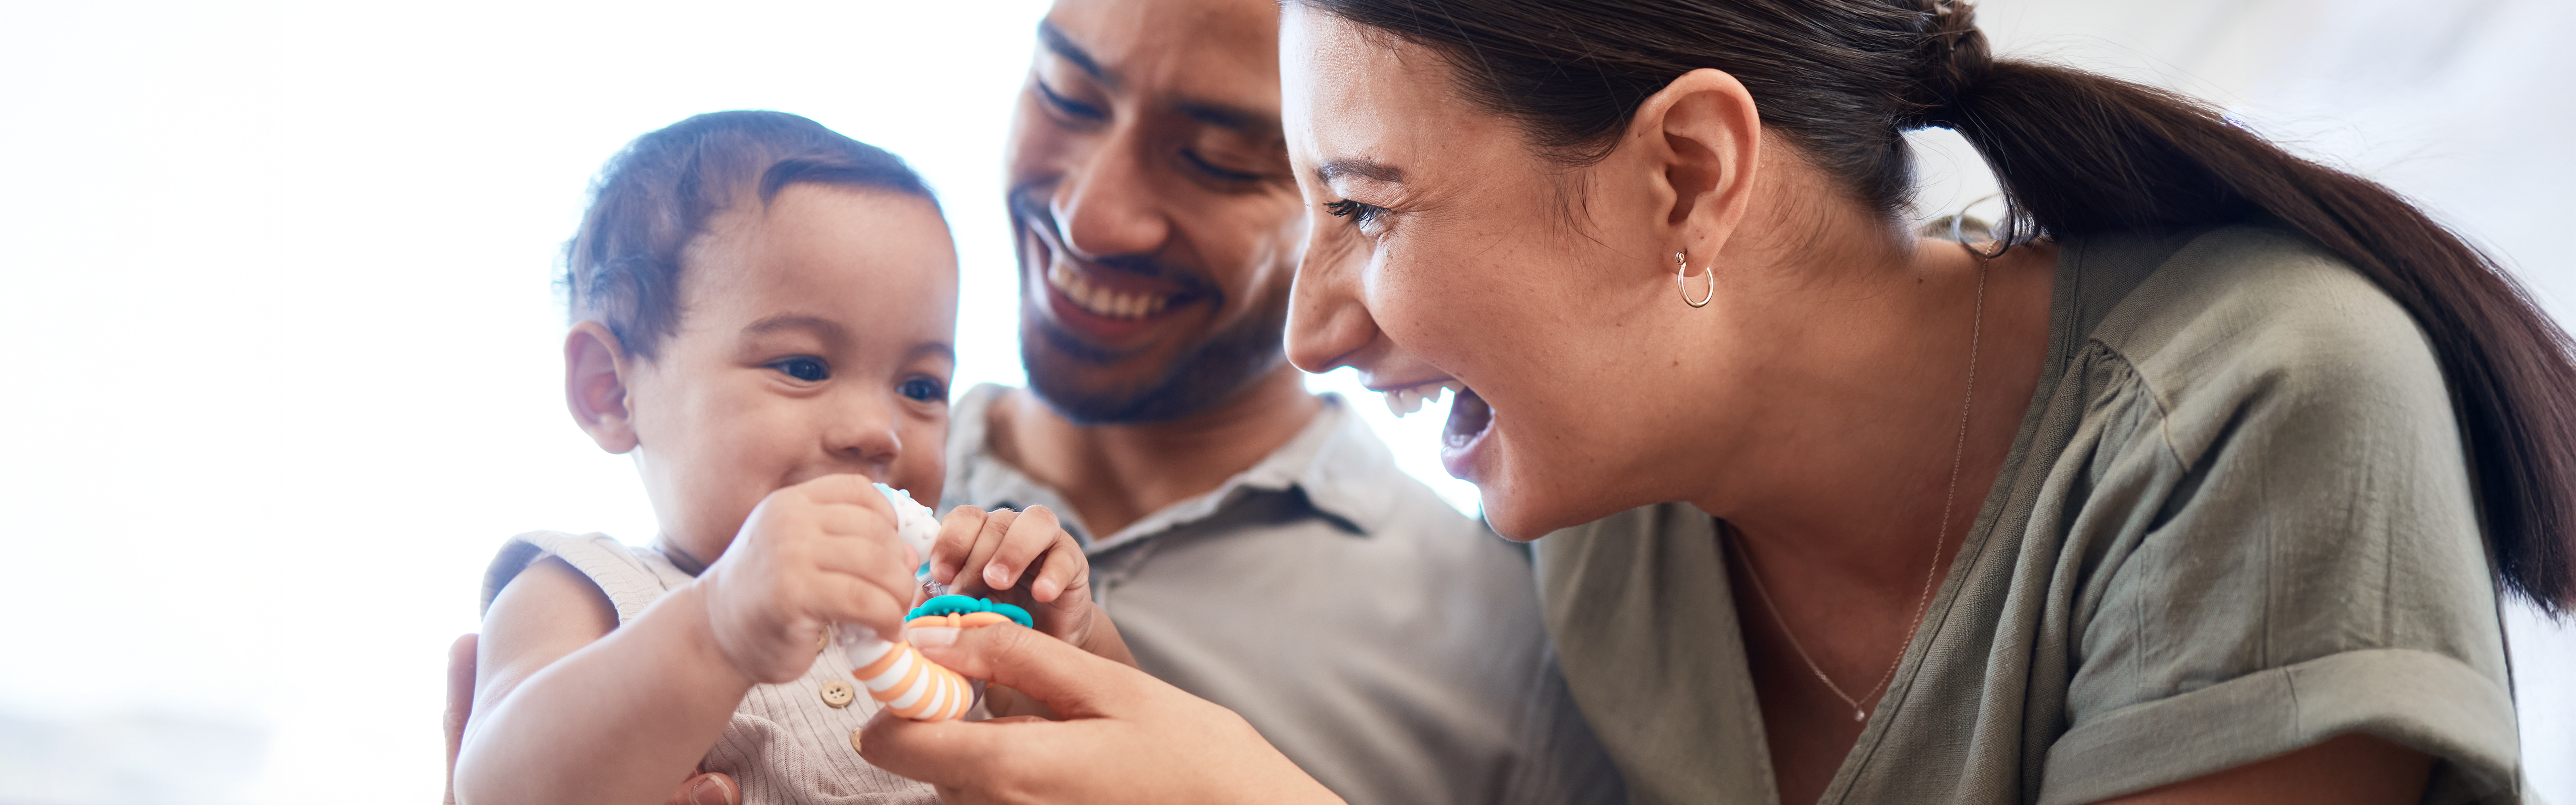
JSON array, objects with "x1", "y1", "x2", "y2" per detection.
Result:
[{"x1": 943, "y1": 384, "x2": 1409, "y2": 552}]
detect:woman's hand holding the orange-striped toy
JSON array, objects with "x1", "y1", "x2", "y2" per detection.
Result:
[{"x1": 860, "y1": 624, "x2": 1342, "y2": 802}]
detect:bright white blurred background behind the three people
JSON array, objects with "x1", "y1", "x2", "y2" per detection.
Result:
[{"x1": 0, "y1": 0, "x2": 2576, "y2": 802}]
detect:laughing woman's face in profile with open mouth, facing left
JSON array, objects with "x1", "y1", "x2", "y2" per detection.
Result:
[{"x1": 1280, "y1": 3, "x2": 1729, "y2": 539}]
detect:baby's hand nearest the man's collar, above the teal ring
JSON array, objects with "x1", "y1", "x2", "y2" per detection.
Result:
[{"x1": 930, "y1": 506, "x2": 1100, "y2": 648}]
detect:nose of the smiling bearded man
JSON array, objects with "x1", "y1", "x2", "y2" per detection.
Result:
[{"x1": 1051, "y1": 132, "x2": 1172, "y2": 258}]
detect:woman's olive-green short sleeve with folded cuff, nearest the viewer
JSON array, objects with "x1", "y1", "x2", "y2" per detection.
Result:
[{"x1": 2040, "y1": 281, "x2": 2519, "y2": 802}]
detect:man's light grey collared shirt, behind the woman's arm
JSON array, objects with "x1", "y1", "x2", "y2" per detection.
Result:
[{"x1": 943, "y1": 384, "x2": 1626, "y2": 805}]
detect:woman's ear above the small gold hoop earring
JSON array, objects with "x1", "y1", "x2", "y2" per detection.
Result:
[{"x1": 1628, "y1": 67, "x2": 1762, "y2": 263}]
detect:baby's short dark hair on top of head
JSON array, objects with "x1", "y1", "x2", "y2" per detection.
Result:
[{"x1": 556, "y1": 111, "x2": 938, "y2": 361}]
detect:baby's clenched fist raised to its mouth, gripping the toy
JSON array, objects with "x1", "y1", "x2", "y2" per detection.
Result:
[{"x1": 698, "y1": 475, "x2": 920, "y2": 684}]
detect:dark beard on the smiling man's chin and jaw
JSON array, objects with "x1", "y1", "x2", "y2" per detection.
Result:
[{"x1": 1020, "y1": 286, "x2": 1288, "y2": 426}]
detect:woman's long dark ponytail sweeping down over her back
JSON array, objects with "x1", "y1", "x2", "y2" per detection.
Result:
[{"x1": 1929, "y1": 62, "x2": 2576, "y2": 614}]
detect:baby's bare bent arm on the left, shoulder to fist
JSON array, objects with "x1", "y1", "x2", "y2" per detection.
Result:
[{"x1": 456, "y1": 475, "x2": 915, "y2": 805}]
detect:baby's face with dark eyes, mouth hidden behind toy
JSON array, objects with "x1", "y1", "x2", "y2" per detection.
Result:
[{"x1": 626, "y1": 186, "x2": 958, "y2": 565}]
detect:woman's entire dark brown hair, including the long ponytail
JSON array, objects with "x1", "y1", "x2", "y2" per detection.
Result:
[{"x1": 1291, "y1": 0, "x2": 2576, "y2": 614}]
